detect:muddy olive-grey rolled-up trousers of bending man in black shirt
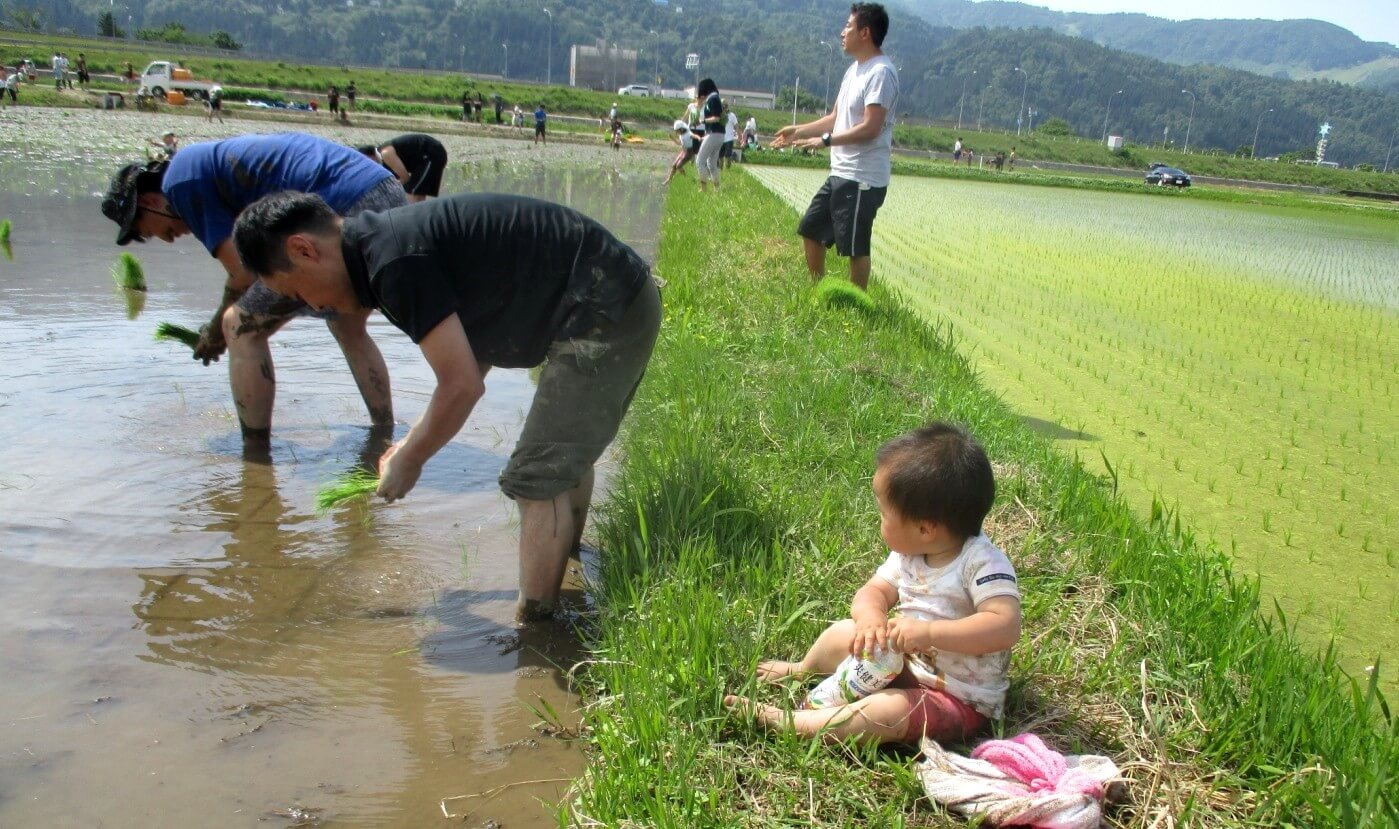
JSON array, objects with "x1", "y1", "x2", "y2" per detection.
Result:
[{"x1": 501, "y1": 277, "x2": 662, "y2": 500}]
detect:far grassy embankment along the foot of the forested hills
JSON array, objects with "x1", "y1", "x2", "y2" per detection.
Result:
[{"x1": 0, "y1": 29, "x2": 1399, "y2": 193}]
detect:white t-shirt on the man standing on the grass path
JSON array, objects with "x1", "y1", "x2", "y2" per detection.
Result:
[{"x1": 831, "y1": 55, "x2": 898, "y2": 187}]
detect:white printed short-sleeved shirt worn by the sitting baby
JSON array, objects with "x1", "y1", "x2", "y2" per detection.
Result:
[{"x1": 874, "y1": 535, "x2": 1020, "y2": 720}]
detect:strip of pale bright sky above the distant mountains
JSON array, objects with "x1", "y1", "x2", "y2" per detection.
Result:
[{"x1": 984, "y1": 0, "x2": 1399, "y2": 43}]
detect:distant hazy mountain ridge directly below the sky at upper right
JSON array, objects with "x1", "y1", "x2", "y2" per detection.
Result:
[{"x1": 898, "y1": 0, "x2": 1399, "y2": 92}]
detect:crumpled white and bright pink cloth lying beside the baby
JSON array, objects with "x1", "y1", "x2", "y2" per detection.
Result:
[{"x1": 918, "y1": 734, "x2": 1119, "y2": 829}]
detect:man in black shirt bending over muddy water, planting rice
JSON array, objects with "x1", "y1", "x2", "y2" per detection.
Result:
[{"x1": 234, "y1": 193, "x2": 660, "y2": 621}]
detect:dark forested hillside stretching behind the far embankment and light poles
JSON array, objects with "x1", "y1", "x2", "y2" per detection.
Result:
[{"x1": 0, "y1": 0, "x2": 1399, "y2": 166}]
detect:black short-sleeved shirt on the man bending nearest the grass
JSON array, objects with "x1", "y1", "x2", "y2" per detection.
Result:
[{"x1": 343, "y1": 193, "x2": 651, "y2": 368}]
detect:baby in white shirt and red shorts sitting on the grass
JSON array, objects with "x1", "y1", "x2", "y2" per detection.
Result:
[{"x1": 723, "y1": 424, "x2": 1020, "y2": 745}]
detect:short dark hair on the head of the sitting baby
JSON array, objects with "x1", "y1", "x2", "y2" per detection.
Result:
[{"x1": 874, "y1": 422, "x2": 996, "y2": 538}]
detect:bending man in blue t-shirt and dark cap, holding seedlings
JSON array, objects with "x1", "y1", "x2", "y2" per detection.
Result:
[{"x1": 102, "y1": 133, "x2": 407, "y2": 447}]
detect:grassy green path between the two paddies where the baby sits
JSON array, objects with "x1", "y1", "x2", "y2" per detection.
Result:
[{"x1": 572, "y1": 173, "x2": 1399, "y2": 826}]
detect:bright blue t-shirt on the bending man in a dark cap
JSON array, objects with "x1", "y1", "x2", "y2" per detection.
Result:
[{"x1": 161, "y1": 133, "x2": 393, "y2": 254}]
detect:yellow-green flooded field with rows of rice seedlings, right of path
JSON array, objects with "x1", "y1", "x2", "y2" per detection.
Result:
[{"x1": 754, "y1": 168, "x2": 1399, "y2": 671}]
